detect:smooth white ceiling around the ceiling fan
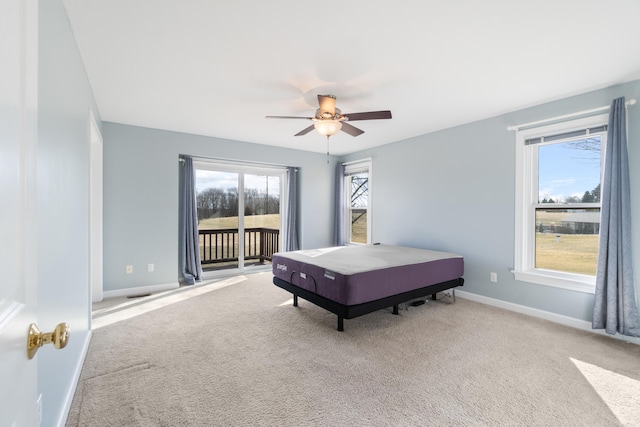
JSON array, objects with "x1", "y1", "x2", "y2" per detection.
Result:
[{"x1": 64, "y1": 0, "x2": 640, "y2": 154}]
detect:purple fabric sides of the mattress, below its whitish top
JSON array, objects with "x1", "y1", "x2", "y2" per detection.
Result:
[{"x1": 272, "y1": 255, "x2": 464, "y2": 305}]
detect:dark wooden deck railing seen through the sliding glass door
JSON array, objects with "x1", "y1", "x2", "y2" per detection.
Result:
[{"x1": 198, "y1": 227, "x2": 280, "y2": 265}]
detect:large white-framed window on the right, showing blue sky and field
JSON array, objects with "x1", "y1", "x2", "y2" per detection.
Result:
[{"x1": 514, "y1": 115, "x2": 607, "y2": 293}]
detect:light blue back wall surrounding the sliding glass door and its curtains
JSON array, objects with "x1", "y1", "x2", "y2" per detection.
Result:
[{"x1": 103, "y1": 122, "x2": 335, "y2": 291}]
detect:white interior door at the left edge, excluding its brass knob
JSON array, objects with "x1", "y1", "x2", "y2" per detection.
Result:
[{"x1": 0, "y1": 0, "x2": 39, "y2": 426}]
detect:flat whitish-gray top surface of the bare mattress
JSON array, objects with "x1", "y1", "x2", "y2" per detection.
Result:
[{"x1": 277, "y1": 245, "x2": 462, "y2": 275}]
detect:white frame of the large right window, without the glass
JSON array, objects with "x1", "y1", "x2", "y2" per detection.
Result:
[{"x1": 512, "y1": 114, "x2": 609, "y2": 294}]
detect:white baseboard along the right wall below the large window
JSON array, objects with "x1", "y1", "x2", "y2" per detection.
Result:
[{"x1": 456, "y1": 289, "x2": 640, "y2": 345}]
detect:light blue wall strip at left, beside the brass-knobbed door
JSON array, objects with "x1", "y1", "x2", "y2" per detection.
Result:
[{"x1": 34, "y1": 0, "x2": 99, "y2": 425}]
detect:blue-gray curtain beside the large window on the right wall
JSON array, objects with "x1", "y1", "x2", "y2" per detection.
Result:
[{"x1": 592, "y1": 97, "x2": 640, "y2": 337}]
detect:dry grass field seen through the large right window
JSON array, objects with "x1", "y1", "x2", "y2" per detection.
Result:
[{"x1": 535, "y1": 210, "x2": 598, "y2": 276}]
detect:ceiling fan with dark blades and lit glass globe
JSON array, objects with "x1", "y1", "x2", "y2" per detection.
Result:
[{"x1": 266, "y1": 95, "x2": 391, "y2": 140}]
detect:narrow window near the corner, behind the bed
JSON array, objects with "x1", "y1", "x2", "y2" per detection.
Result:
[{"x1": 344, "y1": 160, "x2": 371, "y2": 244}]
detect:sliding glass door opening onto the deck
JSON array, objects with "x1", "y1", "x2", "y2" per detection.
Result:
[{"x1": 194, "y1": 160, "x2": 286, "y2": 277}]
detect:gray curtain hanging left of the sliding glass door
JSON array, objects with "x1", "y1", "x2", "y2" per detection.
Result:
[{"x1": 181, "y1": 157, "x2": 202, "y2": 285}]
